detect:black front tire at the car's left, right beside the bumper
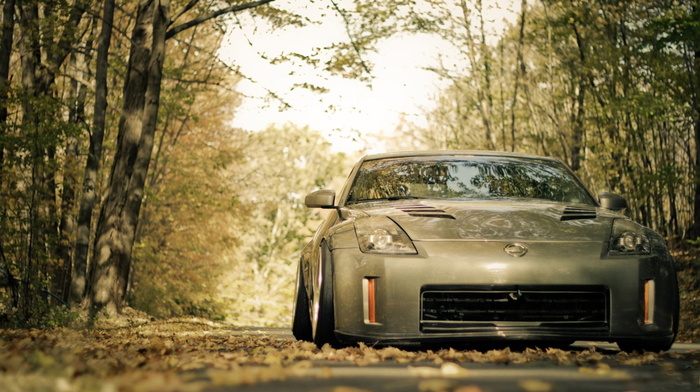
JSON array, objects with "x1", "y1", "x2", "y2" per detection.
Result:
[{"x1": 311, "y1": 242, "x2": 340, "y2": 348}]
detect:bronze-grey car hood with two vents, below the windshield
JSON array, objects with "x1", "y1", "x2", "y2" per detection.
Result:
[{"x1": 348, "y1": 200, "x2": 619, "y2": 241}]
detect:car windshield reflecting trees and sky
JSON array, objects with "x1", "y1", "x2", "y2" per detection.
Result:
[{"x1": 348, "y1": 157, "x2": 595, "y2": 205}]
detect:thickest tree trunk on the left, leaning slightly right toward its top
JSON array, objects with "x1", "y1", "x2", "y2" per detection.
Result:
[{"x1": 86, "y1": 0, "x2": 169, "y2": 315}]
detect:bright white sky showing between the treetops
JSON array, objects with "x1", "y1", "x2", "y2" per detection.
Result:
[{"x1": 221, "y1": 0, "x2": 516, "y2": 152}]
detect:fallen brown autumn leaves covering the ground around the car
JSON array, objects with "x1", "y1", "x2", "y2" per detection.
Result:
[{"x1": 0, "y1": 318, "x2": 700, "y2": 392}]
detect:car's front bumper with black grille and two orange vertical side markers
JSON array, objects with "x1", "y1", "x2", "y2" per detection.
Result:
[{"x1": 332, "y1": 241, "x2": 677, "y2": 344}]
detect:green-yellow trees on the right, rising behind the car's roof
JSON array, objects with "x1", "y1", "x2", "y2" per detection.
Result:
[{"x1": 394, "y1": 0, "x2": 700, "y2": 239}]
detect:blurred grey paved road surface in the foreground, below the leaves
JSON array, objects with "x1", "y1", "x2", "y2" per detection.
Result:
[{"x1": 211, "y1": 329, "x2": 700, "y2": 392}]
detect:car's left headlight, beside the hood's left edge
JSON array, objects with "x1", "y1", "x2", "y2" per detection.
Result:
[{"x1": 355, "y1": 217, "x2": 418, "y2": 255}]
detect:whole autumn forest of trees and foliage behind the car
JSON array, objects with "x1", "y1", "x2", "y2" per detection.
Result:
[{"x1": 0, "y1": 0, "x2": 700, "y2": 340}]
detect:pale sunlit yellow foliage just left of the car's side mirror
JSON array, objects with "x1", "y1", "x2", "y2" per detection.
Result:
[{"x1": 221, "y1": 125, "x2": 346, "y2": 326}]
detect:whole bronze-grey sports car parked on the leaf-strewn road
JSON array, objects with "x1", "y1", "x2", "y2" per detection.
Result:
[{"x1": 292, "y1": 151, "x2": 679, "y2": 351}]
